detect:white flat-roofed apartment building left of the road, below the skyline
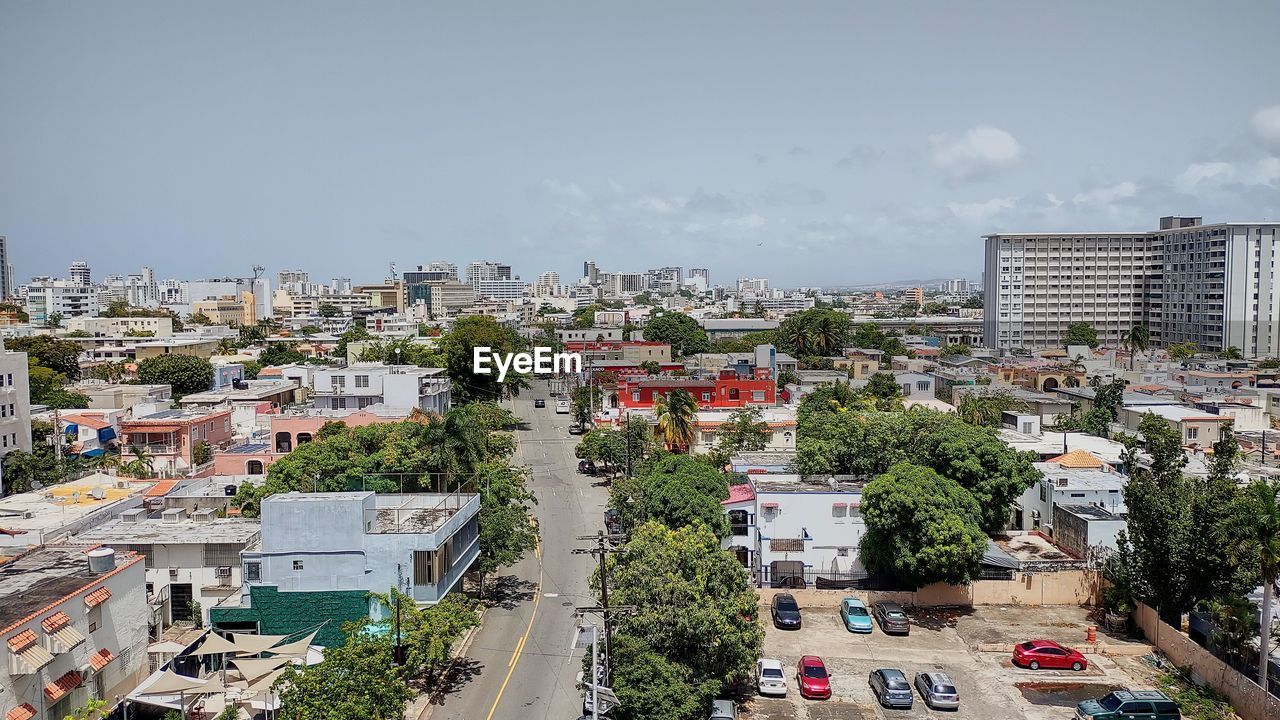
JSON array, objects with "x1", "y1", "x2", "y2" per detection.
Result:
[{"x1": 312, "y1": 363, "x2": 453, "y2": 415}]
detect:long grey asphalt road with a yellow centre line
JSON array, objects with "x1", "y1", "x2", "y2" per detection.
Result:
[{"x1": 430, "y1": 382, "x2": 608, "y2": 720}]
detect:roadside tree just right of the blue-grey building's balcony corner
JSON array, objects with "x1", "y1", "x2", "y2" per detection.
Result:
[{"x1": 472, "y1": 464, "x2": 538, "y2": 594}]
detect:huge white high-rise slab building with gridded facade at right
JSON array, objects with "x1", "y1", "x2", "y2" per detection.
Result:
[{"x1": 983, "y1": 217, "x2": 1280, "y2": 356}]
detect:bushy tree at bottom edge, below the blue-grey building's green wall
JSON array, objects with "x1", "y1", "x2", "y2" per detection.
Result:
[{"x1": 276, "y1": 630, "x2": 412, "y2": 720}]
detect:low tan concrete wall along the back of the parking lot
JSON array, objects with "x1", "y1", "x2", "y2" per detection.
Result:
[{"x1": 759, "y1": 570, "x2": 1101, "y2": 607}]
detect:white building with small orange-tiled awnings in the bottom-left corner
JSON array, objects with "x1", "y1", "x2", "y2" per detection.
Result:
[{"x1": 0, "y1": 546, "x2": 148, "y2": 720}]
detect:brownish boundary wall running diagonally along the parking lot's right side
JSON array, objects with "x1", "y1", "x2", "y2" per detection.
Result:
[{"x1": 1135, "y1": 602, "x2": 1280, "y2": 720}]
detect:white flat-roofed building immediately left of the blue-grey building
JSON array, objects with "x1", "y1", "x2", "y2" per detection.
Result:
[{"x1": 76, "y1": 507, "x2": 261, "y2": 633}]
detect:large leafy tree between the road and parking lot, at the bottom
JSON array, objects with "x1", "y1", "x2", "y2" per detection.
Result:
[{"x1": 591, "y1": 523, "x2": 764, "y2": 707}]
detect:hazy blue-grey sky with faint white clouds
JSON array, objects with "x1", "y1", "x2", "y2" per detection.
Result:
[{"x1": 0, "y1": 0, "x2": 1280, "y2": 287}]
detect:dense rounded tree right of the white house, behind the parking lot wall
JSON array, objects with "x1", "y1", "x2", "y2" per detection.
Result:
[{"x1": 860, "y1": 462, "x2": 987, "y2": 588}]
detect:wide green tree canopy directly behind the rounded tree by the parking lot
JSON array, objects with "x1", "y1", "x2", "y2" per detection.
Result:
[{"x1": 795, "y1": 407, "x2": 1041, "y2": 532}]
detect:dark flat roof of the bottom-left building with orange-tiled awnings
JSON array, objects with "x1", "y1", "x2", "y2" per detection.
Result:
[{"x1": 0, "y1": 544, "x2": 142, "y2": 633}]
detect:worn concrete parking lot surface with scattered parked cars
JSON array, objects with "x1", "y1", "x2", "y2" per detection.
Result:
[{"x1": 744, "y1": 605, "x2": 1144, "y2": 720}]
